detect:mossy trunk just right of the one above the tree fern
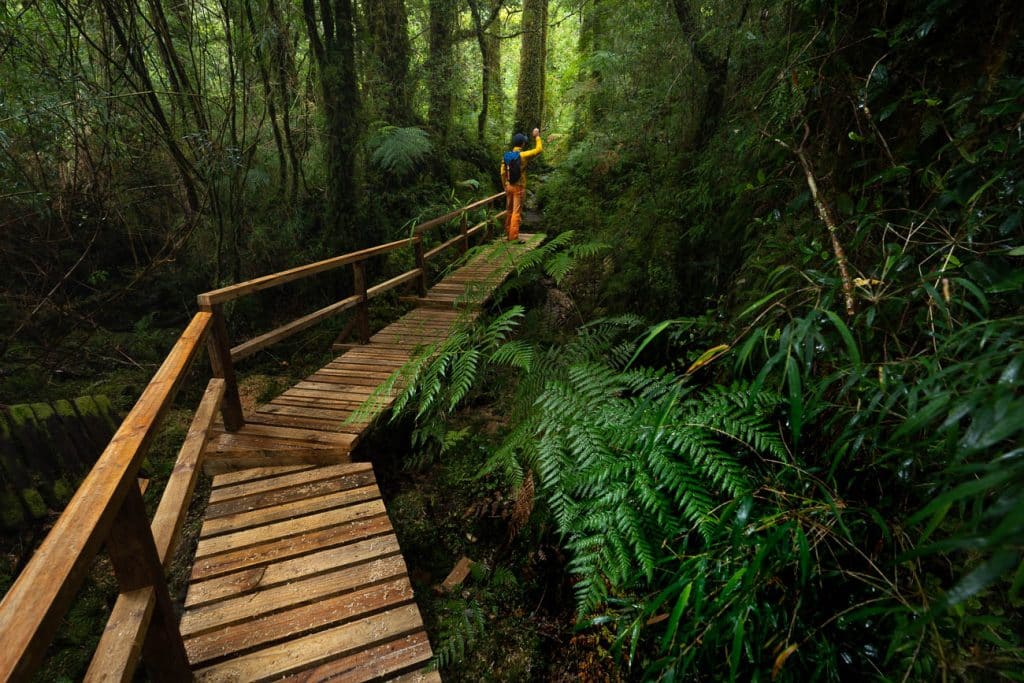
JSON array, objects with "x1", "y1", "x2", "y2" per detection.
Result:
[{"x1": 427, "y1": 0, "x2": 459, "y2": 143}]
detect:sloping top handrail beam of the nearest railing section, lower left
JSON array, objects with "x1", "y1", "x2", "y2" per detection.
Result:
[{"x1": 0, "y1": 311, "x2": 212, "y2": 680}]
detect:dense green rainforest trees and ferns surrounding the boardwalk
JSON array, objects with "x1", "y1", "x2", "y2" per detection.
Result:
[{"x1": 0, "y1": 0, "x2": 1024, "y2": 681}]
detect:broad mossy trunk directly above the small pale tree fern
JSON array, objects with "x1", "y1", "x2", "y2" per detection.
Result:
[{"x1": 366, "y1": 0, "x2": 413, "y2": 125}]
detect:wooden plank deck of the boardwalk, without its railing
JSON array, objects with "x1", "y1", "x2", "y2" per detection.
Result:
[{"x1": 180, "y1": 234, "x2": 544, "y2": 681}]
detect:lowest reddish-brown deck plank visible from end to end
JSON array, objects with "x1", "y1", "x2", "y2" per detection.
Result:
[{"x1": 185, "y1": 578, "x2": 411, "y2": 667}]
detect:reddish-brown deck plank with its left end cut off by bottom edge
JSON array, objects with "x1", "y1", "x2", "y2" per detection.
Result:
[{"x1": 272, "y1": 631, "x2": 432, "y2": 683}]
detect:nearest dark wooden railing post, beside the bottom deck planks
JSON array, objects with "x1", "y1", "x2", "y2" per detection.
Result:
[{"x1": 106, "y1": 482, "x2": 193, "y2": 682}]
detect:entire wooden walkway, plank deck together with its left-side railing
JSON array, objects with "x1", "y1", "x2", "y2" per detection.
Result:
[{"x1": 0, "y1": 189, "x2": 544, "y2": 681}]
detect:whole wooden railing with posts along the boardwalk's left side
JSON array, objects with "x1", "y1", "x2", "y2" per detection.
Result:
[{"x1": 0, "y1": 194, "x2": 504, "y2": 681}]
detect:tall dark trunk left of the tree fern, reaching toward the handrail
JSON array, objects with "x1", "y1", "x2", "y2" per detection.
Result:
[{"x1": 302, "y1": 0, "x2": 362, "y2": 249}]
